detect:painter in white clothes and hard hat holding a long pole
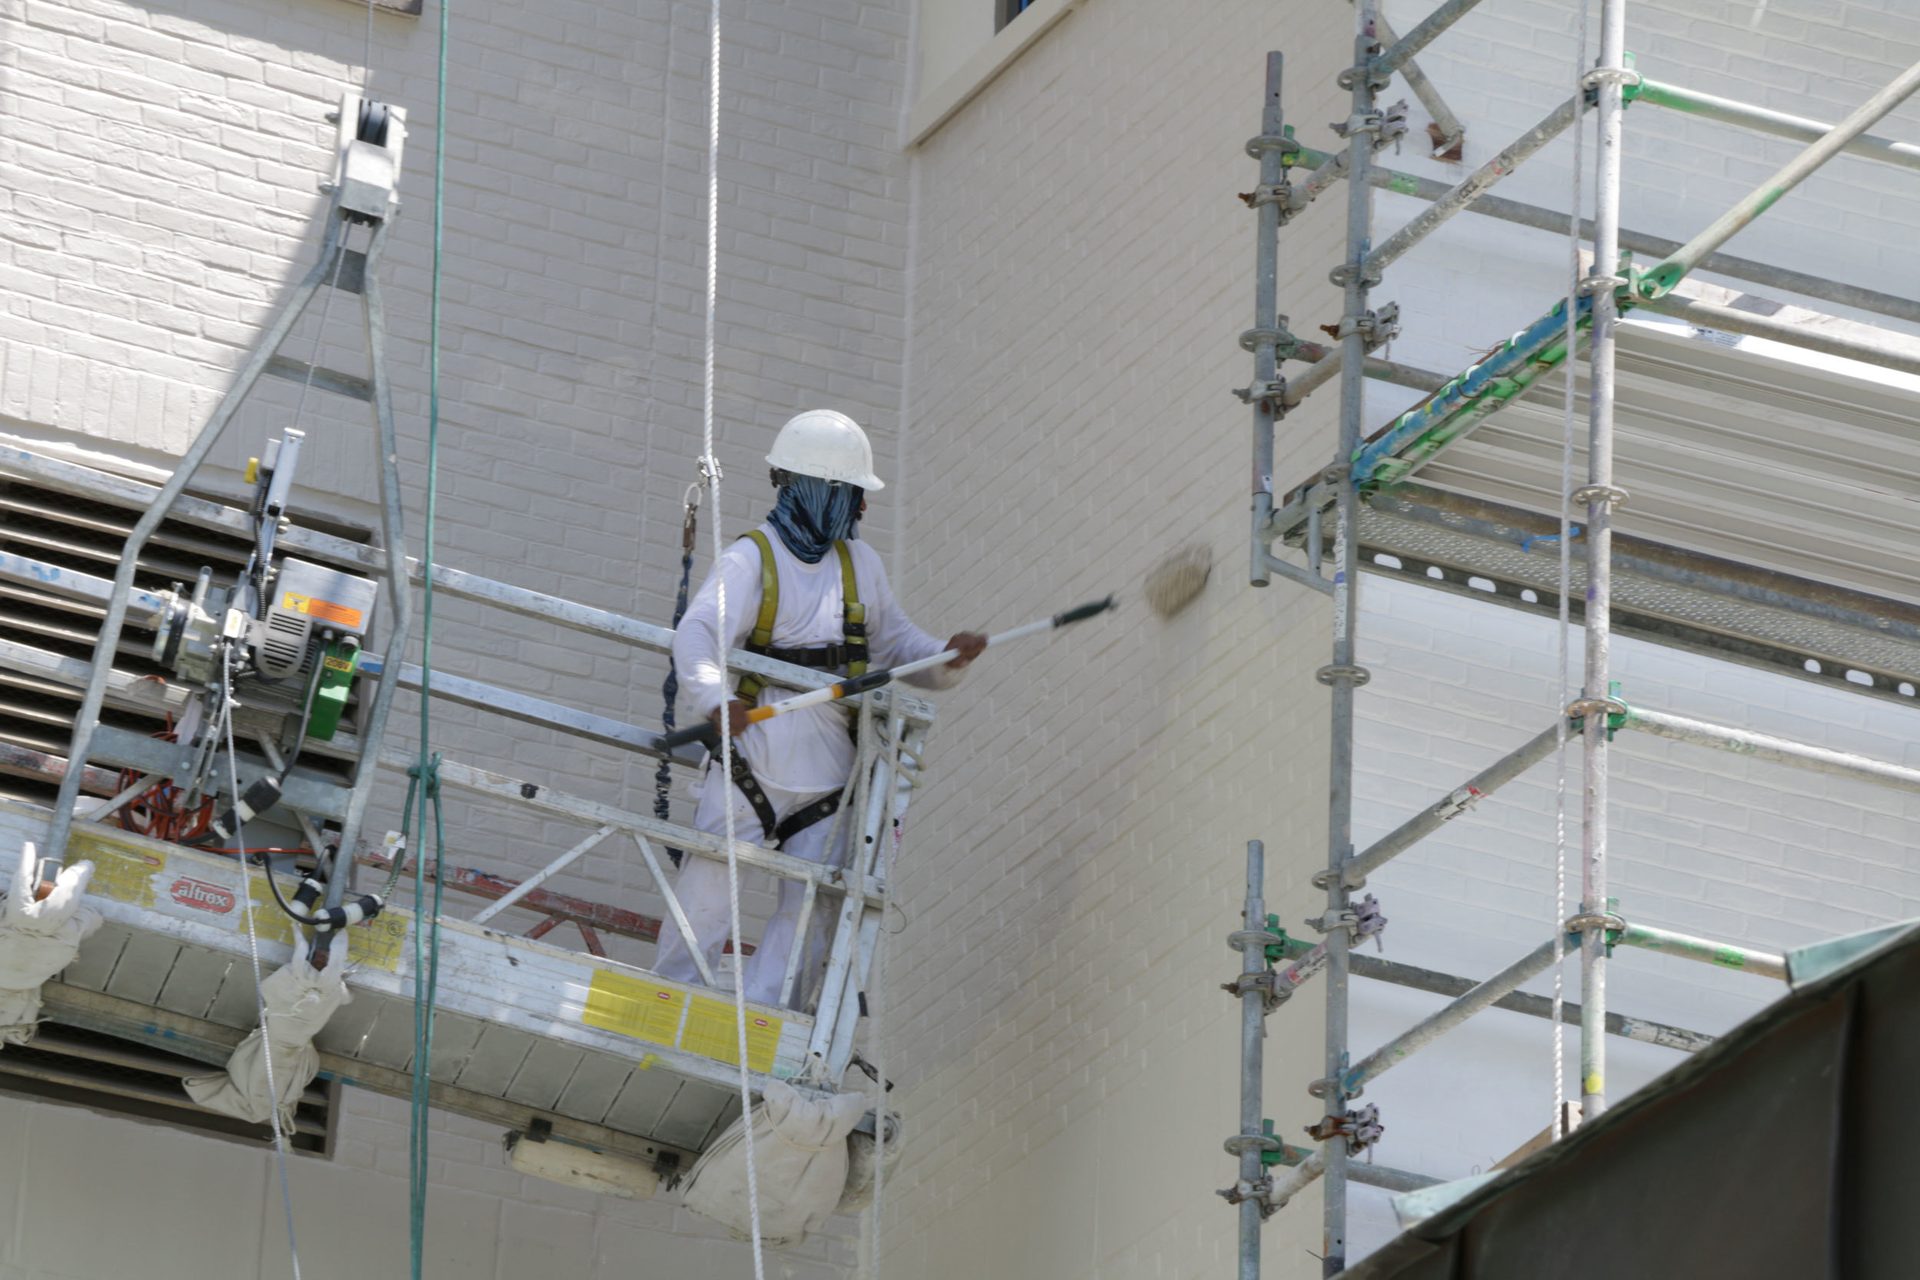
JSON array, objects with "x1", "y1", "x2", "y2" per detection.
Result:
[{"x1": 653, "y1": 409, "x2": 987, "y2": 1007}]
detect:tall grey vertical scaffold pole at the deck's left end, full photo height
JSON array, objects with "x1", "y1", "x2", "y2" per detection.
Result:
[{"x1": 1319, "y1": 0, "x2": 1384, "y2": 1276}]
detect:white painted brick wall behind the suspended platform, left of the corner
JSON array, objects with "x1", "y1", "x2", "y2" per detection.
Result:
[{"x1": 0, "y1": 0, "x2": 908, "y2": 1280}]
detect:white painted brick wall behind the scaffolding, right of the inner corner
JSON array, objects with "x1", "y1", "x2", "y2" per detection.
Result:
[{"x1": 885, "y1": 0, "x2": 1920, "y2": 1280}]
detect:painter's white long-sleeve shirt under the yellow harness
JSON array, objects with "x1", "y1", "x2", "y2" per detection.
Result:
[{"x1": 674, "y1": 524, "x2": 962, "y2": 793}]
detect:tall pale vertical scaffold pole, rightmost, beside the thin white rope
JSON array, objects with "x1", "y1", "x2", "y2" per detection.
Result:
[{"x1": 1574, "y1": 0, "x2": 1630, "y2": 1119}]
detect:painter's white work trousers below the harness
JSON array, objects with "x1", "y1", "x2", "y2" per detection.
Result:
[{"x1": 653, "y1": 760, "x2": 847, "y2": 1009}]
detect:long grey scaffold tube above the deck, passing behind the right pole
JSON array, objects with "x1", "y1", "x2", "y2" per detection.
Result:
[{"x1": 1288, "y1": 148, "x2": 1920, "y2": 324}]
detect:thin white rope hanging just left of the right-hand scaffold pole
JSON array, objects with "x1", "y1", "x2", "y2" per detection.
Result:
[{"x1": 1548, "y1": 0, "x2": 1599, "y2": 1138}]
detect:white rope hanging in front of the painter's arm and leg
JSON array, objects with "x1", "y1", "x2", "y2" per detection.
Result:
[{"x1": 701, "y1": 0, "x2": 774, "y2": 1280}]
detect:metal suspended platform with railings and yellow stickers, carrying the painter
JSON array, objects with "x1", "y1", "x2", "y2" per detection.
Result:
[{"x1": 0, "y1": 443, "x2": 933, "y2": 1155}]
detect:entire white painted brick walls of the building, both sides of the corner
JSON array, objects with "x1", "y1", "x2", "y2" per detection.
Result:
[{"x1": 15, "y1": 0, "x2": 1920, "y2": 1280}]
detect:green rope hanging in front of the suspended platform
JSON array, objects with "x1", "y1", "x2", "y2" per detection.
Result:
[{"x1": 401, "y1": 0, "x2": 451, "y2": 1280}]
